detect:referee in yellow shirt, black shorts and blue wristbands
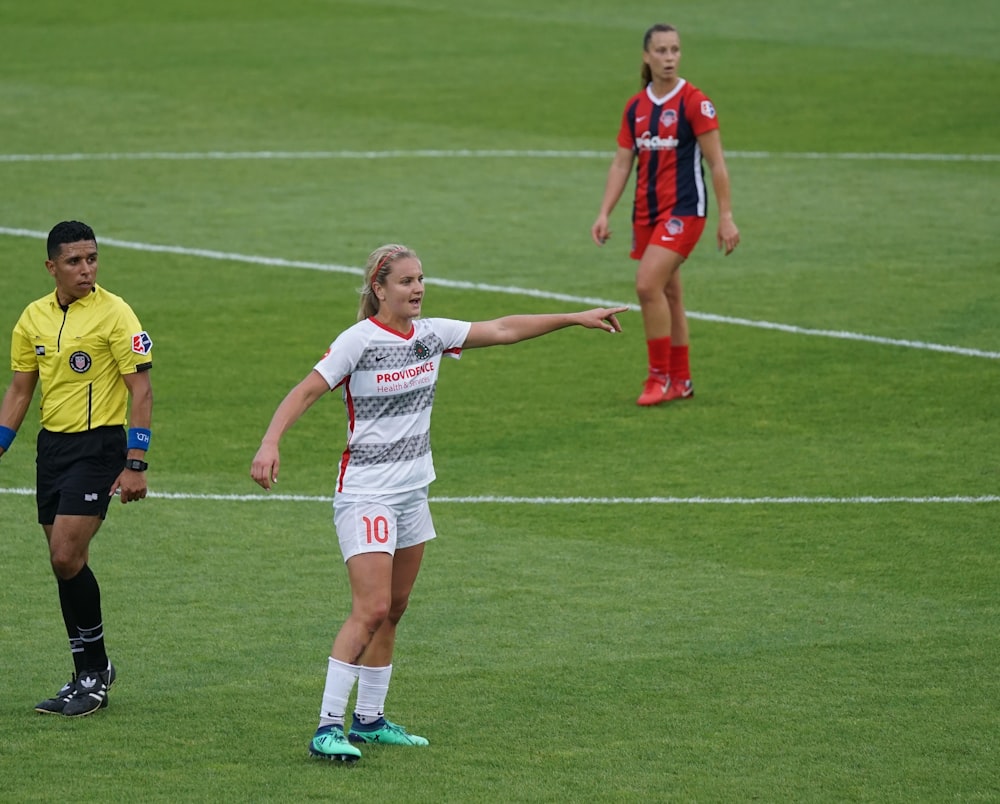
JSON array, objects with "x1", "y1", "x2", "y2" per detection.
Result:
[{"x1": 0, "y1": 221, "x2": 153, "y2": 717}]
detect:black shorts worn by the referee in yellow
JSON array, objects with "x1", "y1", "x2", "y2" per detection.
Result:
[{"x1": 35, "y1": 426, "x2": 128, "y2": 525}]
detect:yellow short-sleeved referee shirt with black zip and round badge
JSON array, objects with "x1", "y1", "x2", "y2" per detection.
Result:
[{"x1": 10, "y1": 285, "x2": 153, "y2": 433}]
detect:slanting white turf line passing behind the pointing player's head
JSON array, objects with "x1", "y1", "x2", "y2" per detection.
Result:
[{"x1": 0, "y1": 226, "x2": 1000, "y2": 360}]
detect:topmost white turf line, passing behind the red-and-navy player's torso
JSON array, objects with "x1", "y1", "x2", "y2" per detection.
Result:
[{"x1": 0, "y1": 149, "x2": 1000, "y2": 162}]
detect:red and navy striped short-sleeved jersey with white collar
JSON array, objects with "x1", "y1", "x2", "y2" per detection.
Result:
[{"x1": 618, "y1": 78, "x2": 719, "y2": 225}]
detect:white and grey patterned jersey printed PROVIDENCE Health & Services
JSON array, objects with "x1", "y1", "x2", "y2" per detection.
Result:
[{"x1": 315, "y1": 318, "x2": 472, "y2": 494}]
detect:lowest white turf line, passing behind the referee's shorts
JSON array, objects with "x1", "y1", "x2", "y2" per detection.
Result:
[{"x1": 0, "y1": 488, "x2": 1000, "y2": 505}]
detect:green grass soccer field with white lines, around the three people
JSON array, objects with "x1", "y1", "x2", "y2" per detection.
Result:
[{"x1": 0, "y1": 0, "x2": 1000, "y2": 802}]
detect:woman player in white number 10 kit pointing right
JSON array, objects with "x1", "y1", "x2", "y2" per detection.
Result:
[{"x1": 250, "y1": 244, "x2": 628, "y2": 762}]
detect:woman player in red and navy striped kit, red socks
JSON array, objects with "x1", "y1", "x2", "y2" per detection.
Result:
[{"x1": 590, "y1": 25, "x2": 740, "y2": 405}]
